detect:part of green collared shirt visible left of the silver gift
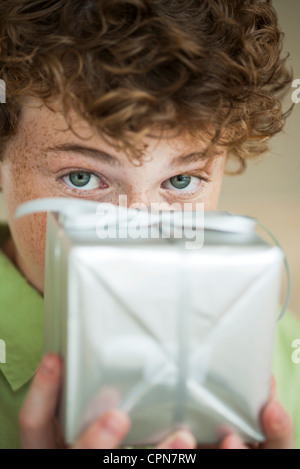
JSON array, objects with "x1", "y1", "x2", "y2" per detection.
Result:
[{"x1": 0, "y1": 224, "x2": 43, "y2": 449}]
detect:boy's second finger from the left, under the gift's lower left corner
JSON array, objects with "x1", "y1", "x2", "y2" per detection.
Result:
[{"x1": 72, "y1": 410, "x2": 130, "y2": 449}]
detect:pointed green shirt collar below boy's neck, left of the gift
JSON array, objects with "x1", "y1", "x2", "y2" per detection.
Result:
[{"x1": 0, "y1": 225, "x2": 44, "y2": 391}]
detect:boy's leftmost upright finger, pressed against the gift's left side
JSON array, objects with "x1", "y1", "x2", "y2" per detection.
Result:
[{"x1": 19, "y1": 354, "x2": 62, "y2": 449}]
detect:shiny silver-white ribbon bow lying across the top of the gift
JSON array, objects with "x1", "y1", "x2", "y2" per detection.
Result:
[{"x1": 15, "y1": 197, "x2": 257, "y2": 234}]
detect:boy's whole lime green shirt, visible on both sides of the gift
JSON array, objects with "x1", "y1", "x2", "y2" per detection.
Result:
[{"x1": 0, "y1": 224, "x2": 300, "y2": 449}]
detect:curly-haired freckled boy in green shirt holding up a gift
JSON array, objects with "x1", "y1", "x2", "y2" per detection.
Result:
[{"x1": 0, "y1": 0, "x2": 300, "y2": 448}]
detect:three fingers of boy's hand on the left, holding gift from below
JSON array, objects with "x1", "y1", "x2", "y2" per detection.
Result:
[{"x1": 19, "y1": 354, "x2": 196, "y2": 449}]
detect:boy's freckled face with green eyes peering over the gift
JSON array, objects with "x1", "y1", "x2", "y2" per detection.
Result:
[{"x1": 0, "y1": 97, "x2": 226, "y2": 292}]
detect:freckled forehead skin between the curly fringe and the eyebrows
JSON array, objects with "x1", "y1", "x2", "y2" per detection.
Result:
[{"x1": 19, "y1": 98, "x2": 216, "y2": 165}]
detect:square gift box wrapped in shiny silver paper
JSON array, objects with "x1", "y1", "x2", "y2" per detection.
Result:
[{"x1": 15, "y1": 199, "x2": 283, "y2": 446}]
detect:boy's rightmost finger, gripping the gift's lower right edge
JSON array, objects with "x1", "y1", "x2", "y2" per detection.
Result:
[{"x1": 262, "y1": 401, "x2": 294, "y2": 449}]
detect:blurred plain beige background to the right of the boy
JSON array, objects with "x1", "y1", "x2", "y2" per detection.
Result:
[{"x1": 0, "y1": 0, "x2": 300, "y2": 316}]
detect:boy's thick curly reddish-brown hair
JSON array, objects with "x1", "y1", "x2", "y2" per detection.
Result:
[{"x1": 0, "y1": 0, "x2": 292, "y2": 172}]
